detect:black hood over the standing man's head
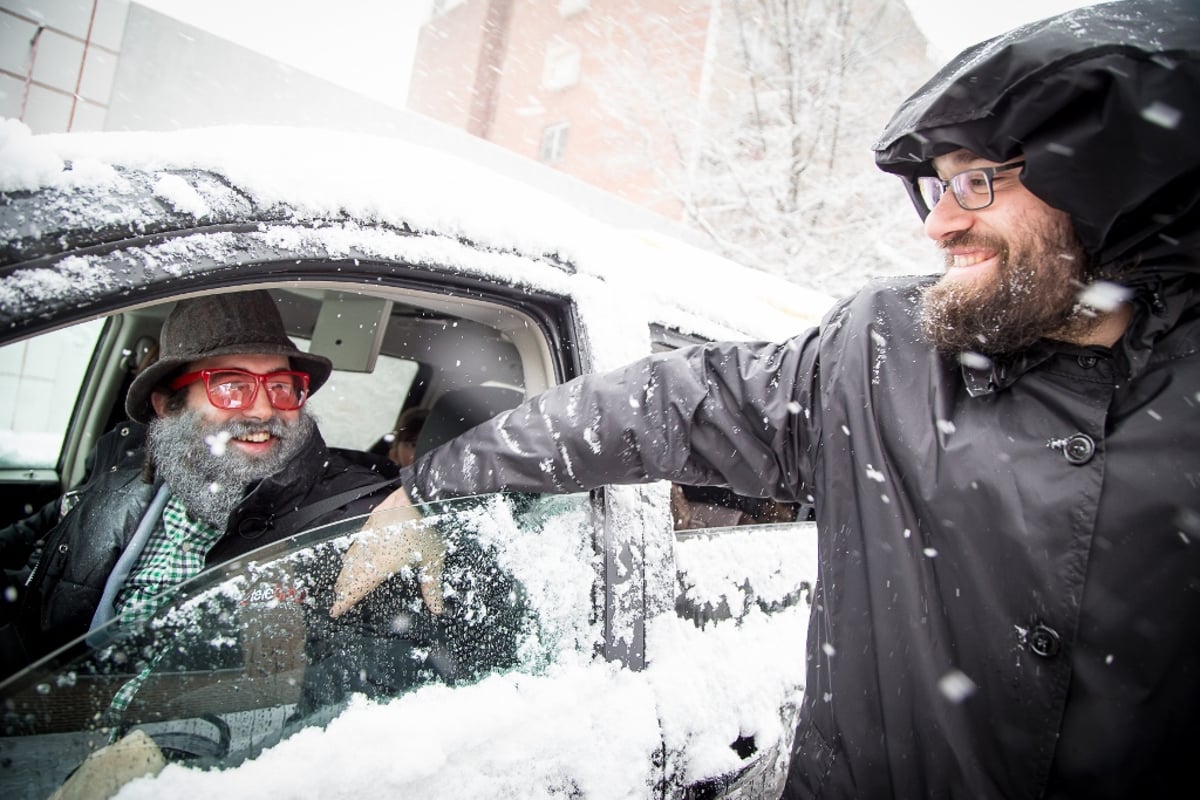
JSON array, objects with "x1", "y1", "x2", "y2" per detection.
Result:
[{"x1": 874, "y1": 0, "x2": 1200, "y2": 278}]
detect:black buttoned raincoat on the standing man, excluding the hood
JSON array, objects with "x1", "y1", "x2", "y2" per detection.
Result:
[{"x1": 406, "y1": 272, "x2": 1200, "y2": 800}]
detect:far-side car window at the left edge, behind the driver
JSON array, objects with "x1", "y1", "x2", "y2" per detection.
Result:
[{"x1": 0, "y1": 320, "x2": 103, "y2": 469}]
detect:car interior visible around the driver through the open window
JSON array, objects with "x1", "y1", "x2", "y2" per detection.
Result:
[{"x1": 0, "y1": 283, "x2": 559, "y2": 532}]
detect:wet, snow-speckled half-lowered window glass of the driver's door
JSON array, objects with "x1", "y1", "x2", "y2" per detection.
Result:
[{"x1": 0, "y1": 494, "x2": 601, "y2": 798}]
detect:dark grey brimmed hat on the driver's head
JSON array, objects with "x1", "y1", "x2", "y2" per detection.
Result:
[{"x1": 125, "y1": 289, "x2": 334, "y2": 422}]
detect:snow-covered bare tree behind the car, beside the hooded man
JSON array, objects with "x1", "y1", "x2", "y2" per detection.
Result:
[{"x1": 593, "y1": 0, "x2": 934, "y2": 294}]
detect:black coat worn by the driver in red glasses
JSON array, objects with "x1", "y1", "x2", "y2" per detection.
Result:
[{"x1": 4, "y1": 426, "x2": 397, "y2": 673}]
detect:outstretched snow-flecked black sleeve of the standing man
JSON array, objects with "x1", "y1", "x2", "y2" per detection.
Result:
[{"x1": 403, "y1": 330, "x2": 820, "y2": 501}]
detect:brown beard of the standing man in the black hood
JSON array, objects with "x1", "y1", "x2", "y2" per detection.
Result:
[{"x1": 920, "y1": 216, "x2": 1100, "y2": 355}]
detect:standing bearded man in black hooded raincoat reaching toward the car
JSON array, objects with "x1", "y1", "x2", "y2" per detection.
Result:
[{"x1": 340, "y1": 0, "x2": 1200, "y2": 800}]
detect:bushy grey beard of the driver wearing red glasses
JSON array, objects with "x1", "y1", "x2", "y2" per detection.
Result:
[{"x1": 146, "y1": 409, "x2": 316, "y2": 530}]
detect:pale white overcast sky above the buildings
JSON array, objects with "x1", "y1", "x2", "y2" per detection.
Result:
[{"x1": 139, "y1": 0, "x2": 1104, "y2": 106}]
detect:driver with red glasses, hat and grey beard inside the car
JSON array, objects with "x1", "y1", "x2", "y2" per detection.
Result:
[{"x1": 0, "y1": 290, "x2": 396, "y2": 674}]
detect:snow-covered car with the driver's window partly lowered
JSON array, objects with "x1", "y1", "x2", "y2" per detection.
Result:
[{"x1": 0, "y1": 122, "x2": 829, "y2": 798}]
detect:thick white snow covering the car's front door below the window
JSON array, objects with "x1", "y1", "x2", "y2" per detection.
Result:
[{"x1": 118, "y1": 664, "x2": 658, "y2": 800}]
